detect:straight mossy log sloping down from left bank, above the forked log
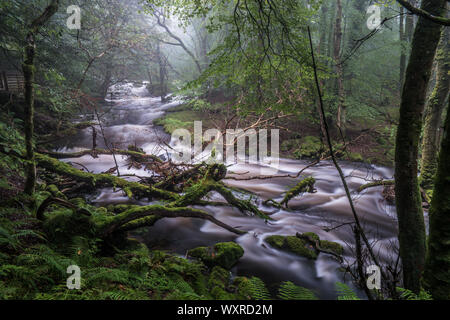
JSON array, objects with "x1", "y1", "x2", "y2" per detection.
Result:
[{"x1": 36, "y1": 154, "x2": 180, "y2": 200}]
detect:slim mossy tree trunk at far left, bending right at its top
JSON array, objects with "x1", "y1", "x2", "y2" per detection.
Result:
[{"x1": 22, "y1": 0, "x2": 59, "y2": 195}]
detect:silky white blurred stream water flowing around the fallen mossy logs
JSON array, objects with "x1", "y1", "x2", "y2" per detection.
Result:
[{"x1": 53, "y1": 84, "x2": 397, "y2": 299}]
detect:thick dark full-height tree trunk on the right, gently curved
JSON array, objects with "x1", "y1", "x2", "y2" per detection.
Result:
[{"x1": 395, "y1": 0, "x2": 446, "y2": 293}]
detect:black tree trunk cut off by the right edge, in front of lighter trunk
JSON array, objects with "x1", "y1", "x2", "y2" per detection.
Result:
[{"x1": 425, "y1": 101, "x2": 450, "y2": 300}]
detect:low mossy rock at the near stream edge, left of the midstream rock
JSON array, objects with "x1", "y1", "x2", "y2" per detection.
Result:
[{"x1": 188, "y1": 242, "x2": 244, "y2": 269}]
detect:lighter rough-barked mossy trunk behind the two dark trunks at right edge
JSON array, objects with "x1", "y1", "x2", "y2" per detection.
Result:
[{"x1": 420, "y1": 28, "x2": 450, "y2": 189}]
